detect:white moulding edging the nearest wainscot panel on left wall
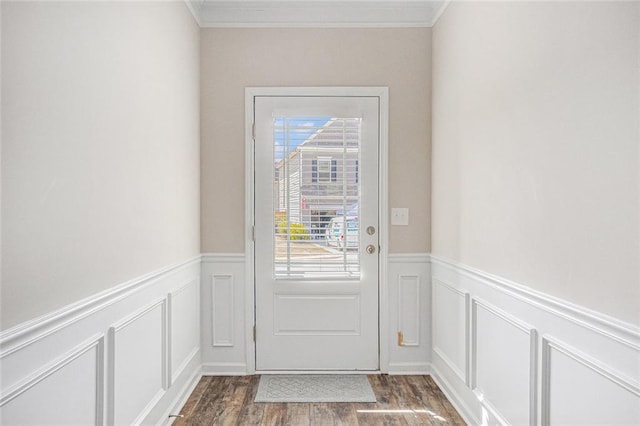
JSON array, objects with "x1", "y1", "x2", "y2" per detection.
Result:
[{"x1": 0, "y1": 334, "x2": 104, "y2": 412}]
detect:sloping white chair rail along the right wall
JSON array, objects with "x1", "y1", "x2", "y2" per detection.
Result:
[{"x1": 431, "y1": 255, "x2": 640, "y2": 350}]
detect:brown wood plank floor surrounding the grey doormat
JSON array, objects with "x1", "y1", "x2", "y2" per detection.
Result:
[{"x1": 174, "y1": 375, "x2": 465, "y2": 426}]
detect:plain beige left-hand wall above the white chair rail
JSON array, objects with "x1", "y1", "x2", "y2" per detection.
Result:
[{"x1": 0, "y1": 2, "x2": 199, "y2": 329}]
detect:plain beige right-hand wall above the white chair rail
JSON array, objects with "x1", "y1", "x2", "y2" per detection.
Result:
[{"x1": 432, "y1": 2, "x2": 640, "y2": 324}]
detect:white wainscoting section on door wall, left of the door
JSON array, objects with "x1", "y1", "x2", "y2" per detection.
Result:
[{"x1": 200, "y1": 253, "x2": 253, "y2": 375}]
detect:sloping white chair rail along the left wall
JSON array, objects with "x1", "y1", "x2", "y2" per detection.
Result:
[{"x1": 0, "y1": 255, "x2": 201, "y2": 359}]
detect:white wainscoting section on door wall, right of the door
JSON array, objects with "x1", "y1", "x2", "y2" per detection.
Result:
[{"x1": 380, "y1": 253, "x2": 431, "y2": 374}]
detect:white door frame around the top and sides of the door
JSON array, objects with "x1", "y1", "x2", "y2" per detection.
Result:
[{"x1": 244, "y1": 87, "x2": 390, "y2": 374}]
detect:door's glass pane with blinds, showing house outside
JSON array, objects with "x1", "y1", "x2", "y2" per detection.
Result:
[{"x1": 273, "y1": 116, "x2": 361, "y2": 279}]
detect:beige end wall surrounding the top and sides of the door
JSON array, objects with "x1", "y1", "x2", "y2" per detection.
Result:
[{"x1": 201, "y1": 29, "x2": 431, "y2": 253}]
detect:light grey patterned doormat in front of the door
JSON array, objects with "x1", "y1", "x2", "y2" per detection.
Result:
[{"x1": 255, "y1": 374, "x2": 376, "y2": 402}]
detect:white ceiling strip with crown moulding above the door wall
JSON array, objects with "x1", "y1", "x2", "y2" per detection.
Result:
[{"x1": 185, "y1": 0, "x2": 450, "y2": 27}]
